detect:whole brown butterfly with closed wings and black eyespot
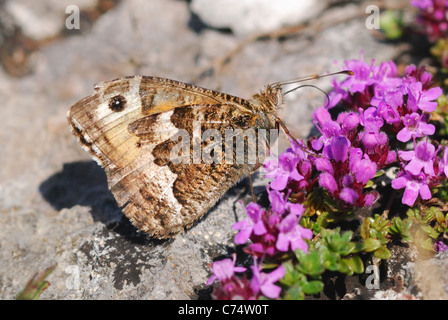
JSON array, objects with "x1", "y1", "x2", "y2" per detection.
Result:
[{"x1": 68, "y1": 71, "x2": 350, "y2": 238}]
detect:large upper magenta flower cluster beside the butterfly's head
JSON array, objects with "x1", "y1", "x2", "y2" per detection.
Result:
[{"x1": 265, "y1": 54, "x2": 448, "y2": 209}]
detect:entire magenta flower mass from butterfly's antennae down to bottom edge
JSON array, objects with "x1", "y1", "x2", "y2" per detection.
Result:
[{"x1": 210, "y1": 53, "x2": 448, "y2": 299}]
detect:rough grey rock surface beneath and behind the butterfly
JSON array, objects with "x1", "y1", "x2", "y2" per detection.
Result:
[{"x1": 0, "y1": 0, "x2": 442, "y2": 299}]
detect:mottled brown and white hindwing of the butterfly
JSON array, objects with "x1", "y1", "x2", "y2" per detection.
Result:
[{"x1": 121, "y1": 104, "x2": 254, "y2": 237}]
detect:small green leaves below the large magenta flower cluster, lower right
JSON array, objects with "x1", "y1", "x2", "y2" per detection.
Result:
[{"x1": 281, "y1": 195, "x2": 448, "y2": 299}]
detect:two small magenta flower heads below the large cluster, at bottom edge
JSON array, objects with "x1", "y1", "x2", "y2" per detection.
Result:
[{"x1": 207, "y1": 187, "x2": 313, "y2": 300}]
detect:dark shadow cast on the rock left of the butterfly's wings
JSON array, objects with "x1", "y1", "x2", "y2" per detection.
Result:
[{"x1": 39, "y1": 161, "x2": 152, "y2": 243}]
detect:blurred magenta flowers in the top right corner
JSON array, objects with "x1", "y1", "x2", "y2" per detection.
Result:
[{"x1": 411, "y1": 0, "x2": 448, "y2": 42}]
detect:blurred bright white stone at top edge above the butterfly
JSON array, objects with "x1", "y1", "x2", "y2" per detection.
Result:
[{"x1": 191, "y1": 0, "x2": 328, "y2": 36}]
